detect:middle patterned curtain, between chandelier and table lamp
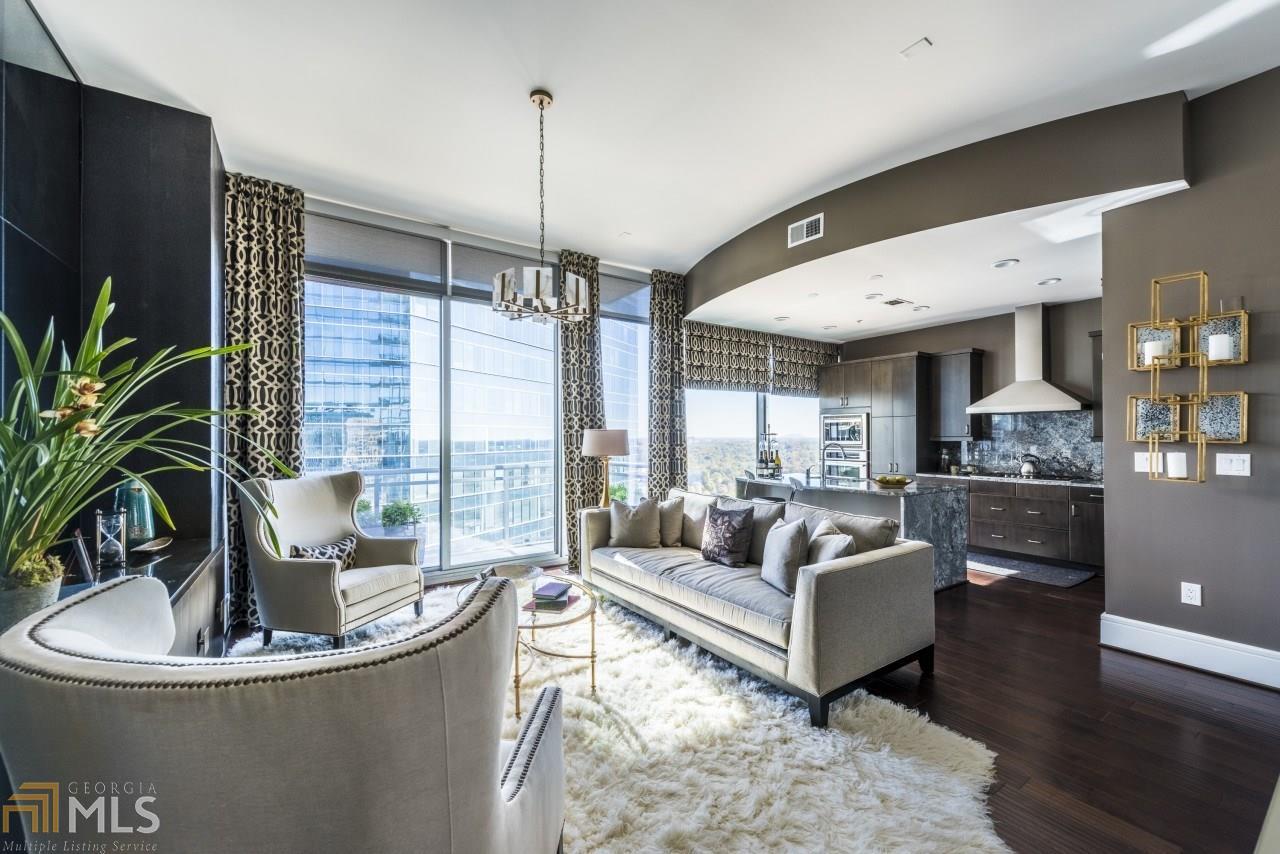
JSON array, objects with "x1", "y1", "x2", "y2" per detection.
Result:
[{"x1": 559, "y1": 250, "x2": 604, "y2": 572}]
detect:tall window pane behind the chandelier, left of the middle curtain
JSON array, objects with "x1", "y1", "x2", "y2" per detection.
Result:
[{"x1": 449, "y1": 300, "x2": 559, "y2": 565}]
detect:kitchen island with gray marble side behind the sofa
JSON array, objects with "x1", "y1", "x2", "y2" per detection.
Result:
[{"x1": 792, "y1": 480, "x2": 969, "y2": 590}]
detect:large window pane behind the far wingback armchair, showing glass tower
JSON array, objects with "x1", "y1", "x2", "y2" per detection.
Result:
[{"x1": 302, "y1": 277, "x2": 440, "y2": 566}]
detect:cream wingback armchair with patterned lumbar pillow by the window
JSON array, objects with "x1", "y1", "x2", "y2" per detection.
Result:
[{"x1": 241, "y1": 471, "x2": 422, "y2": 649}]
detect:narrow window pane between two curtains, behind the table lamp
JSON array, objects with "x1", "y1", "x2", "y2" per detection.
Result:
[{"x1": 600, "y1": 318, "x2": 650, "y2": 503}]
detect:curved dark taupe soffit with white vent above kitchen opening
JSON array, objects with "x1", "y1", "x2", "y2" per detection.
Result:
[{"x1": 685, "y1": 92, "x2": 1187, "y2": 314}]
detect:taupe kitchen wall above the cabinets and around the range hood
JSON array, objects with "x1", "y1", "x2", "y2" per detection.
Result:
[{"x1": 840, "y1": 300, "x2": 1102, "y2": 399}]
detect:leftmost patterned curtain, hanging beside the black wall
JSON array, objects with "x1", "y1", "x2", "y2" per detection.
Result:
[{"x1": 223, "y1": 174, "x2": 303, "y2": 627}]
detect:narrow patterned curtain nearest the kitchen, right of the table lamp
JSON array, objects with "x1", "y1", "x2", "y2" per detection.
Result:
[{"x1": 649, "y1": 270, "x2": 689, "y2": 501}]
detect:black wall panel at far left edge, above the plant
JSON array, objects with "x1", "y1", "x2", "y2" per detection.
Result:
[{"x1": 0, "y1": 63, "x2": 81, "y2": 401}]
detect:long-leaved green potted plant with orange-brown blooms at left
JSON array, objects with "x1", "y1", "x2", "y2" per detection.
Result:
[{"x1": 0, "y1": 279, "x2": 293, "y2": 631}]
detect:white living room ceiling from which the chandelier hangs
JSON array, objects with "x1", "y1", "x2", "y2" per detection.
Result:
[{"x1": 33, "y1": 0, "x2": 1280, "y2": 271}]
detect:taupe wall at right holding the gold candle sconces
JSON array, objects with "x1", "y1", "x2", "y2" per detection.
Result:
[{"x1": 1102, "y1": 69, "x2": 1280, "y2": 649}]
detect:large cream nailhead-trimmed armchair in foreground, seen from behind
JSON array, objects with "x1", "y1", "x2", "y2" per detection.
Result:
[{"x1": 0, "y1": 576, "x2": 564, "y2": 854}]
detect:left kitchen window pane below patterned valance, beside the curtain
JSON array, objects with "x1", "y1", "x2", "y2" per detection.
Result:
[{"x1": 685, "y1": 389, "x2": 756, "y2": 495}]
